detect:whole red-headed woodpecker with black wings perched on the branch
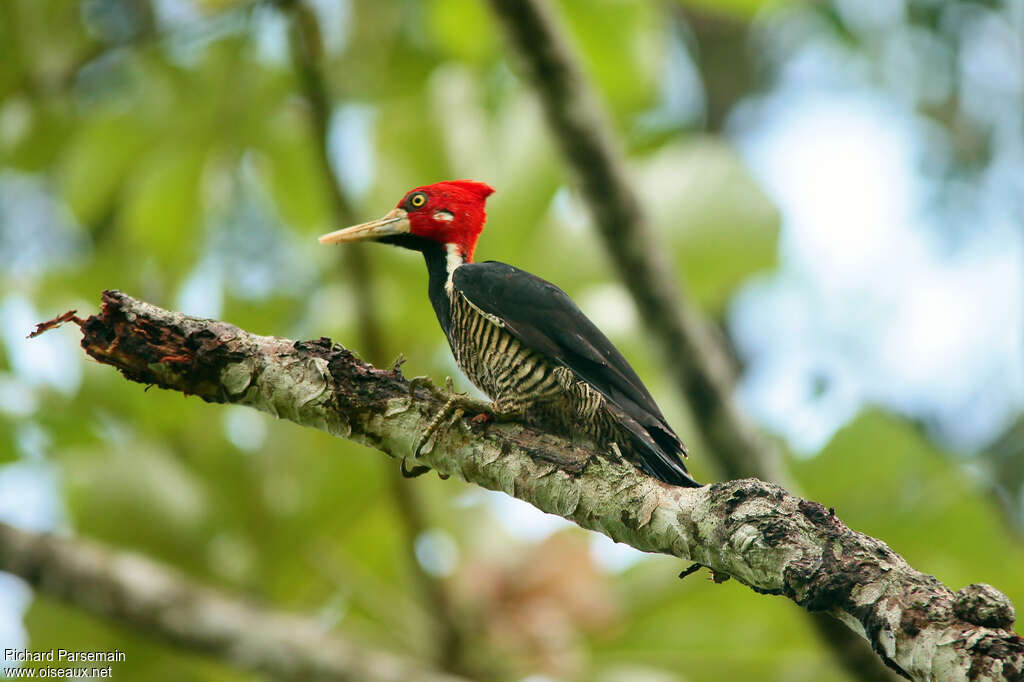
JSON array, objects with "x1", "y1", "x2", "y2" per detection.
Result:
[{"x1": 319, "y1": 180, "x2": 700, "y2": 487}]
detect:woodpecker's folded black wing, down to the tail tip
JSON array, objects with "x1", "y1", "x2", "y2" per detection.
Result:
[{"x1": 453, "y1": 261, "x2": 698, "y2": 485}]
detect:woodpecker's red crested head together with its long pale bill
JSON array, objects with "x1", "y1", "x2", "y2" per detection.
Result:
[{"x1": 321, "y1": 180, "x2": 495, "y2": 262}]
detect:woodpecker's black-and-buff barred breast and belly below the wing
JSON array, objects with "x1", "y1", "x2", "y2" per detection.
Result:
[{"x1": 449, "y1": 291, "x2": 626, "y2": 462}]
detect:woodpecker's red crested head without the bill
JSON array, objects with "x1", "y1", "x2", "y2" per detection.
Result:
[{"x1": 396, "y1": 180, "x2": 495, "y2": 262}]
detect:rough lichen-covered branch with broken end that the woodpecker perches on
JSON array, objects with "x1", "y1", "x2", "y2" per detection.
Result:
[{"x1": 41, "y1": 292, "x2": 1024, "y2": 680}]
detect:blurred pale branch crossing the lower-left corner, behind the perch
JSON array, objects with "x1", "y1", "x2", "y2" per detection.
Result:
[{"x1": 0, "y1": 523, "x2": 465, "y2": 682}]
